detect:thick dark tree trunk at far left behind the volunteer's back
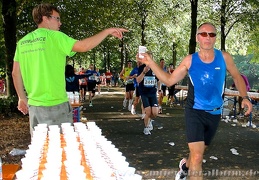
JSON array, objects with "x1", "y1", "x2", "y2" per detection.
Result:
[{"x1": 2, "y1": 0, "x2": 16, "y2": 96}]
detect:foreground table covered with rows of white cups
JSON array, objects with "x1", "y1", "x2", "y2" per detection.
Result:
[{"x1": 16, "y1": 122, "x2": 142, "y2": 180}]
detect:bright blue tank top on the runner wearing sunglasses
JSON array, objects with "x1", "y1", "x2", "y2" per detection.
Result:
[{"x1": 186, "y1": 49, "x2": 226, "y2": 114}]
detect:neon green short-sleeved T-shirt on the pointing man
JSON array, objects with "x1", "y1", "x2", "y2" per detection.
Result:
[{"x1": 14, "y1": 28, "x2": 77, "y2": 106}]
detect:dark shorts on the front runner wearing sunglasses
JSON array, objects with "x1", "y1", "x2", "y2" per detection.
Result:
[{"x1": 185, "y1": 108, "x2": 221, "y2": 146}]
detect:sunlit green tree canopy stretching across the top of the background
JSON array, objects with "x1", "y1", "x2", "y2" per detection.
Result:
[{"x1": 9, "y1": 0, "x2": 258, "y2": 69}]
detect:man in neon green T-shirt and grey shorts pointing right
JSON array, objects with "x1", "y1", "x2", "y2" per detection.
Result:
[{"x1": 12, "y1": 3, "x2": 127, "y2": 132}]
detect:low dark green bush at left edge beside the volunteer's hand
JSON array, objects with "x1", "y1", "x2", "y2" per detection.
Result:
[{"x1": 0, "y1": 96, "x2": 18, "y2": 115}]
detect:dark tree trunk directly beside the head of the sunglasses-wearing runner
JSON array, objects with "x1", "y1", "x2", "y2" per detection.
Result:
[{"x1": 189, "y1": 0, "x2": 198, "y2": 54}]
